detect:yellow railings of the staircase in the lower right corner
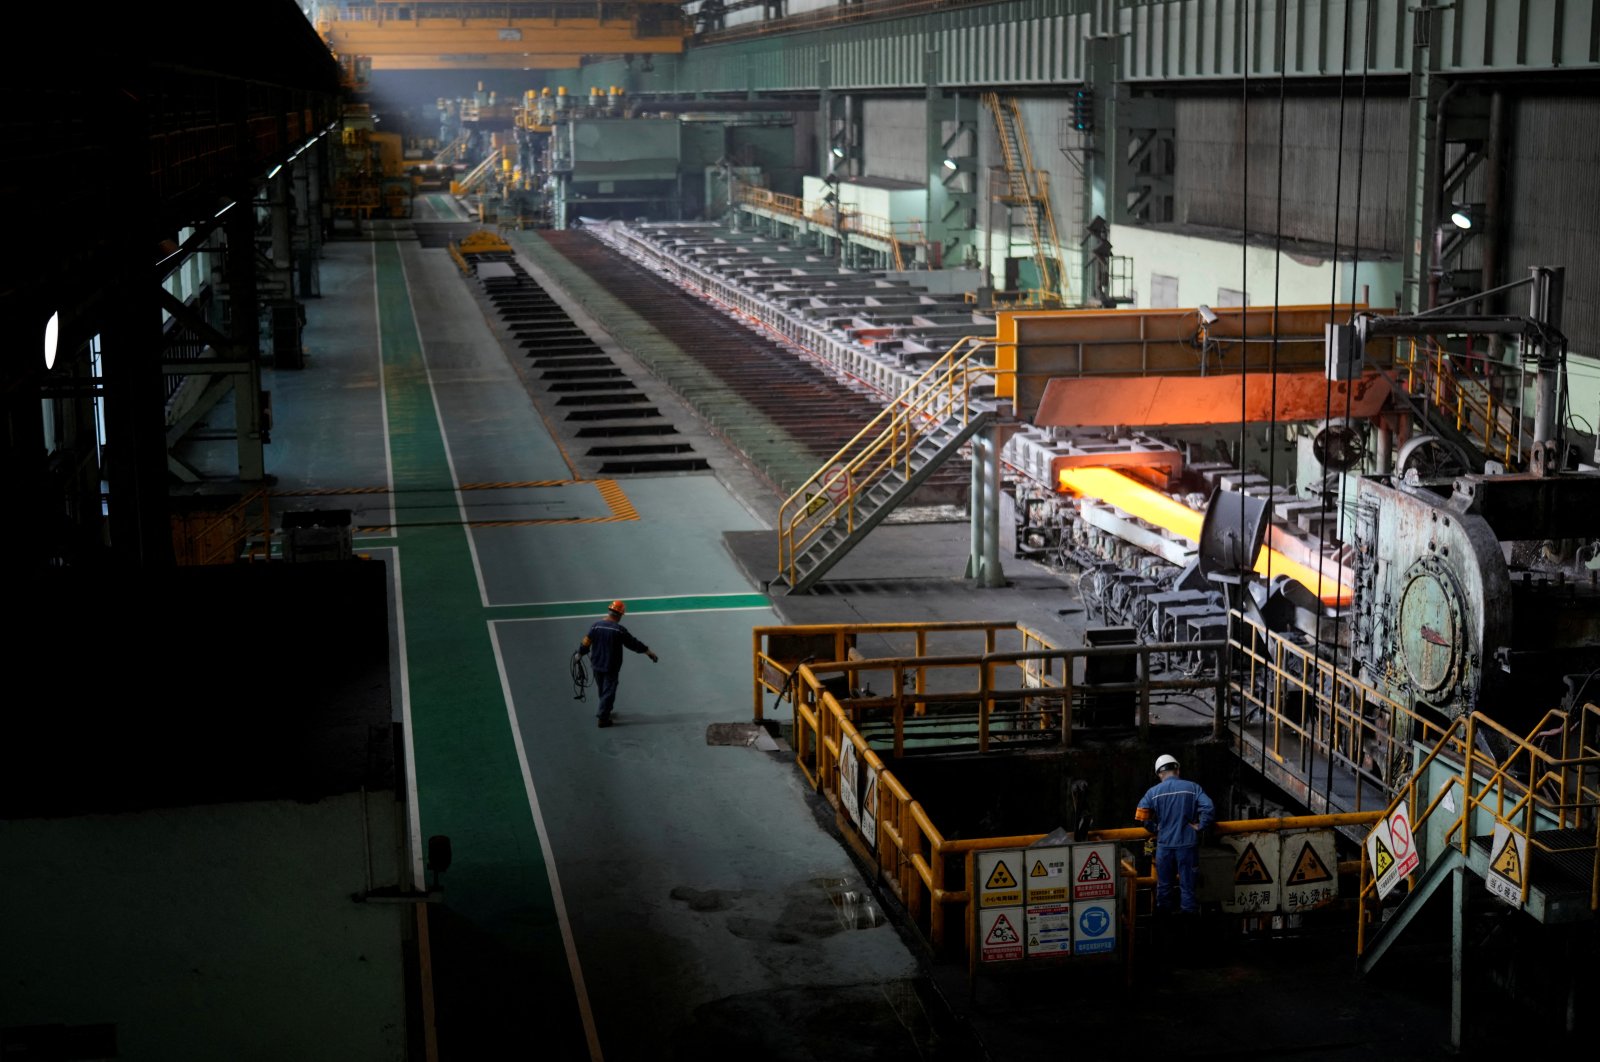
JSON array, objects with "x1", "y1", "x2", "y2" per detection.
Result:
[{"x1": 1355, "y1": 704, "x2": 1600, "y2": 953}]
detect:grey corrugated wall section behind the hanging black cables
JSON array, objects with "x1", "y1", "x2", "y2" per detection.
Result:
[{"x1": 1174, "y1": 96, "x2": 1411, "y2": 254}]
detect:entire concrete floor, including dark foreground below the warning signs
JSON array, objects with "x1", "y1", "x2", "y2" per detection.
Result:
[{"x1": 216, "y1": 197, "x2": 1561, "y2": 1060}]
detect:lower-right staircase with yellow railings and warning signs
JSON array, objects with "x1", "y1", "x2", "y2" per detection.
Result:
[{"x1": 1357, "y1": 704, "x2": 1600, "y2": 974}]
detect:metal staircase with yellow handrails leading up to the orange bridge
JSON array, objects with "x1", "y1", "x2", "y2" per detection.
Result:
[{"x1": 768, "y1": 337, "x2": 994, "y2": 593}]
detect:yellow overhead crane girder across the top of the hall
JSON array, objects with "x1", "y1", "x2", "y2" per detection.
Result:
[{"x1": 317, "y1": 0, "x2": 690, "y2": 70}]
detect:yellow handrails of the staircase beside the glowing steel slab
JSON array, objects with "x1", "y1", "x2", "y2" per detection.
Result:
[{"x1": 778, "y1": 336, "x2": 995, "y2": 585}]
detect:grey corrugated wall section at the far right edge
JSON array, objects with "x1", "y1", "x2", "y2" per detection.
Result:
[{"x1": 1504, "y1": 98, "x2": 1600, "y2": 355}]
